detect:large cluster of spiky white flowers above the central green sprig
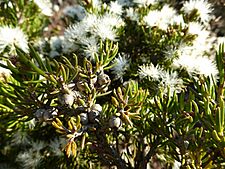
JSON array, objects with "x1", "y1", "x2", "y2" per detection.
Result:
[{"x1": 63, "y1": 13, "x2": 124, "y2": 48}]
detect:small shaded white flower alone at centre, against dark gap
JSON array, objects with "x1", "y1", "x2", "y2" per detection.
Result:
[{"x1": 112, "y1": 54, "x2": 130, "y2": 81}]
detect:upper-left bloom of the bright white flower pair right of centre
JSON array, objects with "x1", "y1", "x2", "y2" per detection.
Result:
[{"x1": 138, "y1": 63, "x2": 163, "y2": 80}]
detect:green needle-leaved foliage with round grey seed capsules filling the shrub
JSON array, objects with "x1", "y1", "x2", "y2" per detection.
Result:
[{"x1": 0, "y1": 0, "x2": 225, "y2": 169}]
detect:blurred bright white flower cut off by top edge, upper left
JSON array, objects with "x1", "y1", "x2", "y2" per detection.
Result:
[{"x1": 34, "y1": 0, "x2": 53, "y2": 16}]
